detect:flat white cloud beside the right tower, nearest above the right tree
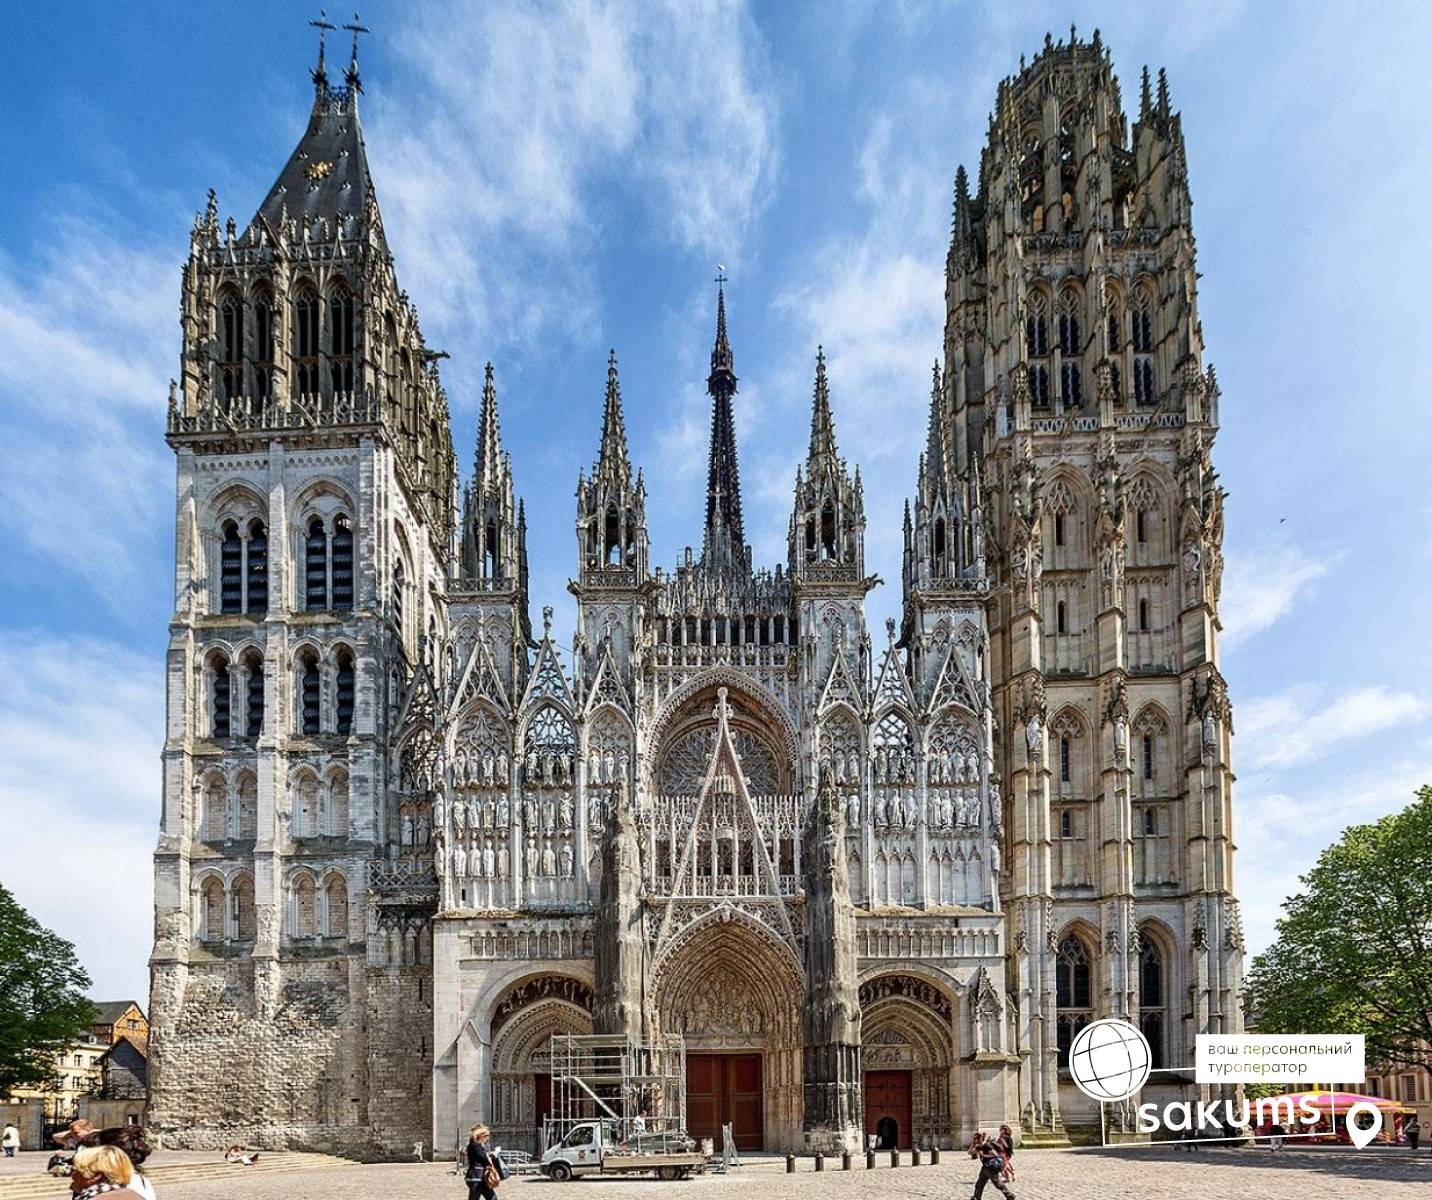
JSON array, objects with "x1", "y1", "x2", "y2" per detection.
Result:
[{"x1": 1237, "y1": 684, "x2": 1432, "y2": 770}]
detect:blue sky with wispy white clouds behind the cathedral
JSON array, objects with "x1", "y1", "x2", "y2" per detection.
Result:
[{"x1": 0, "y1": 0, "x2": 1432, "y2": 1000}]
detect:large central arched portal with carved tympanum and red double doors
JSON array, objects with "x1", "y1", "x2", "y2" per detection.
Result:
[{"x1": 653, "y1": 908, "x2": 803, "y2": 1150}]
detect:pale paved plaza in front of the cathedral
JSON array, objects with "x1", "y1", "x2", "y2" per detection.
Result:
[{"x1": 8, "y1": 1147, "x2": 1432, "y2": 1200}]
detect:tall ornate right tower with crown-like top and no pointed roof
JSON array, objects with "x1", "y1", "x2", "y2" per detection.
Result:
[{"x1": 945, "y1": 32, "x2": 1242, "y2": 1127}]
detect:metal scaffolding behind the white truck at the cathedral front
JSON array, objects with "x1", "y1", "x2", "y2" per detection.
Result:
[{"x1": 543, "y1": 1034, "x2": 687, "y2": 1153}]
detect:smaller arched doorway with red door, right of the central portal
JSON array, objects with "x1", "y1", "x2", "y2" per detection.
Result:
[{"x1": 861, "y1": 975, "x2": 954, "y2": 1150}]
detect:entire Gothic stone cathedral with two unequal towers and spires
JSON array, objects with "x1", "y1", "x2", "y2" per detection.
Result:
[{"x1": 150, "y1": 32, "x2": 1243, "y2": 1156}]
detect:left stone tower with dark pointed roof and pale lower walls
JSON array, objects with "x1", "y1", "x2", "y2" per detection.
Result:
[{"x1": 150, "y1": 30, "x2": 461, "y2": 1151}]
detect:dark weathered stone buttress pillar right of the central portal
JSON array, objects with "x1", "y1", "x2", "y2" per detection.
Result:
[{"x1": 802, "y1": 766, "x2": 865, "y2": 1154}]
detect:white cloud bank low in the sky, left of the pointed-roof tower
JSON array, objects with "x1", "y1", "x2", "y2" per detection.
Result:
[{"x1": 0, "y1": 632, "x2": 165, "y2": 1002}]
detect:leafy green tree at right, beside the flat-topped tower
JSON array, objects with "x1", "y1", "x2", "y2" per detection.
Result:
[{"x1": 1244, "y1": 788, "x2": 1432, "y2": 1073}]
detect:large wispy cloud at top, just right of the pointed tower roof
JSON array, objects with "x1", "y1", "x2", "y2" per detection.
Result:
[{"x1": 367, "y1": 0, "x2": 778, "y2": 362}]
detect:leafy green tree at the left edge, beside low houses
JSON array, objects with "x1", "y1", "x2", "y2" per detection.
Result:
[{"x1": 0, "y1": 884, "x2": 95, "y2": 1095}]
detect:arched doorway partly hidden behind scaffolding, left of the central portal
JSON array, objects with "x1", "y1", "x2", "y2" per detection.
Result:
[{"x1": 487, "y1": 975, "x2": 591, "y2": 1151}]
